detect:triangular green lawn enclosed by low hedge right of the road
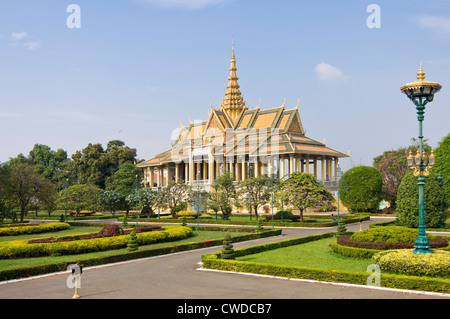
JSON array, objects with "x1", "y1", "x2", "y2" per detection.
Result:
[{"x1": 236, "y1": 237, "x2": 373, "y2": 272}]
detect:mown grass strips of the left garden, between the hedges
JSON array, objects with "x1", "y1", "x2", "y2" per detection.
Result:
[{"x1": 0, "y1": 230, "x2": 246, "y2": 270}]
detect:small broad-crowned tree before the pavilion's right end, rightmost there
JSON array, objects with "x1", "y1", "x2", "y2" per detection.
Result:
[{"x1": 279, "y1": 172, "x2": 334, "y2": 222}]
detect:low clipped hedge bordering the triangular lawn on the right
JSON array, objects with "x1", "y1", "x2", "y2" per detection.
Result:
[{"x1": 202, "y1": 233, "x2": 450, "y2": 293}]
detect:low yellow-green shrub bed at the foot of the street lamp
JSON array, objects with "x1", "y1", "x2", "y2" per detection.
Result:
[{"x1": 372, "y1": 249, "x2": 450, "y2": 276}]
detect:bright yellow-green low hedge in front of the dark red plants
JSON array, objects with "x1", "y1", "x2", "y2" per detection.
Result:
[{"x1": 0, "y1": 226, "x2": 192, "y2": 259}]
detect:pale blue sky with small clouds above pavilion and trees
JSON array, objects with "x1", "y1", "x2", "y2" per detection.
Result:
[{"x1": 0, "y1": 0, "x2": 450, "y2": 174}]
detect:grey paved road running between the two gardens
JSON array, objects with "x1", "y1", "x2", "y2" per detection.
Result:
[{"x1": 0, "y1": 221, "x2": 450, "y2": 300}]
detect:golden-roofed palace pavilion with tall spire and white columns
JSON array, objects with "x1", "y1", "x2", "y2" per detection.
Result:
[{"x1": 138, "y1": 44, "x2": 348, "y2": 195}]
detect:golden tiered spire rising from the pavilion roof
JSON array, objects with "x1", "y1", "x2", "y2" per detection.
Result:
[{"x1": 220, "y1": 38, "x2": 246, "y2": 120}]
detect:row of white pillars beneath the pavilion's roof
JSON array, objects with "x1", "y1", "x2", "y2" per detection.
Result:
[{"x1": 144, "y1": 154, "x2": 338, "y2": 187}]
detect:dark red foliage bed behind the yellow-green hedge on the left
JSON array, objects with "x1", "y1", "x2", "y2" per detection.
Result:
[{"x1": 28, "y1": 225, "x2": 164, "y2": 244}]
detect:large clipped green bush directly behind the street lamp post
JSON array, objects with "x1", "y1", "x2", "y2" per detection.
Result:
[{"x1": 396, "y1": 170, "x2": 442, "y2": 228}]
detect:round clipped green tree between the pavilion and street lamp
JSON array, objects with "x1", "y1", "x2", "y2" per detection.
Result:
[{"x1": 339, "y1": 166, "x2": 383, "y2": 212}]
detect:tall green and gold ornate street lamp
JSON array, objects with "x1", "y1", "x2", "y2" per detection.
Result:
[{"x1": 400, "y1": 63, "x2": 442, "y2": 254}]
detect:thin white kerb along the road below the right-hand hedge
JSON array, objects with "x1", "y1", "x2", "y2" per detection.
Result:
[{"x1": 197, "y1": 268, "x2": 450, "y2": 298}]
